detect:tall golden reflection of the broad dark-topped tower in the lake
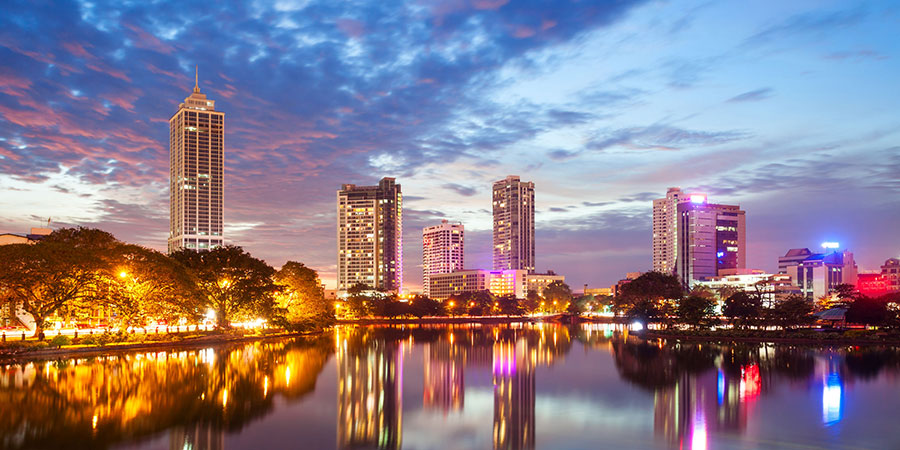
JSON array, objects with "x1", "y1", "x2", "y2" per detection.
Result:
[{"x1": 336, "y1": 332, "x2": 403, "y2": 449}]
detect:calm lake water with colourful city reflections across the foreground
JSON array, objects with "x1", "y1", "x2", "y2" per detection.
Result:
[{"x1": 0, "y1": 324, "x2": 900, "y2": 450}]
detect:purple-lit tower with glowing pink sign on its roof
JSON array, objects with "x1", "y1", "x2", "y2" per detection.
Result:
[{"x1": 675, "y1": 194, "x2": 747, "y2": 286}]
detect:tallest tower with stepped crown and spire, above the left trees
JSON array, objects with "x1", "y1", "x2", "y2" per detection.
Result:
[{"x1": 169, "y1": 69, "x2": 225, "y2": 253}]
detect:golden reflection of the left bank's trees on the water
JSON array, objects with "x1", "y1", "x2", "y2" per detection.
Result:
[{"x1": 0, "y1": 339, "x2": 332, "y2": 448}]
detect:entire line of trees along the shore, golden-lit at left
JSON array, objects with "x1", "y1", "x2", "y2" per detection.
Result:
[{"x1": 0, "y1": 228, "x2": 900, "y2": 356}]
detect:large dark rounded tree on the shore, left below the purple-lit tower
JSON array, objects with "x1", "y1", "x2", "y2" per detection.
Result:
[{"x1": 613, "y1": 272, "x2": 684, "y2": 320}]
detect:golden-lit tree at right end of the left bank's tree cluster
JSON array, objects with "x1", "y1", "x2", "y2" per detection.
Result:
[{"x1": 275, "y1": 261, "x2": 334, "y2": 323}]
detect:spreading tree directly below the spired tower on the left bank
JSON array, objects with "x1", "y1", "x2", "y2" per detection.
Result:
[{"x1": 172, "y1": 246, "x2": 280, "y2": 328}]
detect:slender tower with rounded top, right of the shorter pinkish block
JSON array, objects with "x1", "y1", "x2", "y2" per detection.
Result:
[{"x1": 493, "y1": 175, "x2": 534, "y2": 273}]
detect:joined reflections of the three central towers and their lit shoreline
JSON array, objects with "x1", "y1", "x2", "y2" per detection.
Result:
[{"x1": 337, "y1": 325, "x2": 571, "y2": 449}]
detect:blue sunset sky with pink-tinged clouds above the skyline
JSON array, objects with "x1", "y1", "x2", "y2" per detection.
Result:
[{"x1": 0, "y1": 0, "x2": 900, "y2": 290}]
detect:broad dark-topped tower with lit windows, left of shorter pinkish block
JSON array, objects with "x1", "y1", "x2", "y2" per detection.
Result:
[{"x1": 337, "y1": 178, "x2": 403, "y2": 293}]
